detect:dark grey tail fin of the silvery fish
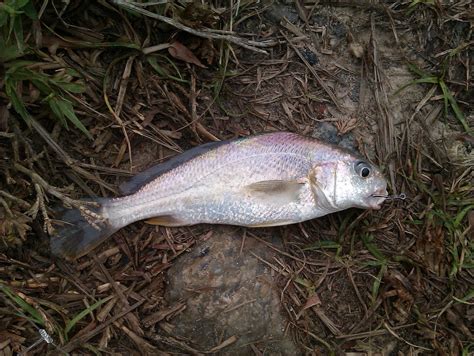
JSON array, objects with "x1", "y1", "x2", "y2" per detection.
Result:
[{"x1": 50, "y1": 199, "x2": 118, "y2": 260}]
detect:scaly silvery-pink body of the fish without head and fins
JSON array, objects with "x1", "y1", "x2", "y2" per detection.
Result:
[{"x1": 105, "y1": 135, "x2": 336, "y2": 228}]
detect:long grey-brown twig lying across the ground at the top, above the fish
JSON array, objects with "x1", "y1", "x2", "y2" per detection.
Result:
[{"x1": 112, "y1": 0, "x2": 276, "y2": 54}]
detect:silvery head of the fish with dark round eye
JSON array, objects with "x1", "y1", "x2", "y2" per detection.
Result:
[{"x1": 314, "y1": 155, "x2": 387, "y2": 211}]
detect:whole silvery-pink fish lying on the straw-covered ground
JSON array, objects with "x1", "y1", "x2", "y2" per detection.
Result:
[{"x1": 50, "y1": 132, "x2": 387, "y2": 260}]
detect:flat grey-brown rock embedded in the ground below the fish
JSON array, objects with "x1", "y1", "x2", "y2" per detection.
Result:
[{"x1": 166, "y1": 227, "x2": 300, "y2": 355}]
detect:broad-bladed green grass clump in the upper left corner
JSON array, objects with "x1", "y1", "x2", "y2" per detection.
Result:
[{"x1": 0, "y1": 0, "x2": 92, "y2": 138}]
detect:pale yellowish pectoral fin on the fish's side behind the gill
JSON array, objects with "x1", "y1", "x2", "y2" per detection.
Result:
[{"x1": 244, "y1": 180, "x2": 304, "y2": 204}]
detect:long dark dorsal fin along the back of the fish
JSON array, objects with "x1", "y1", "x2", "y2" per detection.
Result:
[{"x1": 119, "y1": 138, "x2": 236, "y2": 195}]
